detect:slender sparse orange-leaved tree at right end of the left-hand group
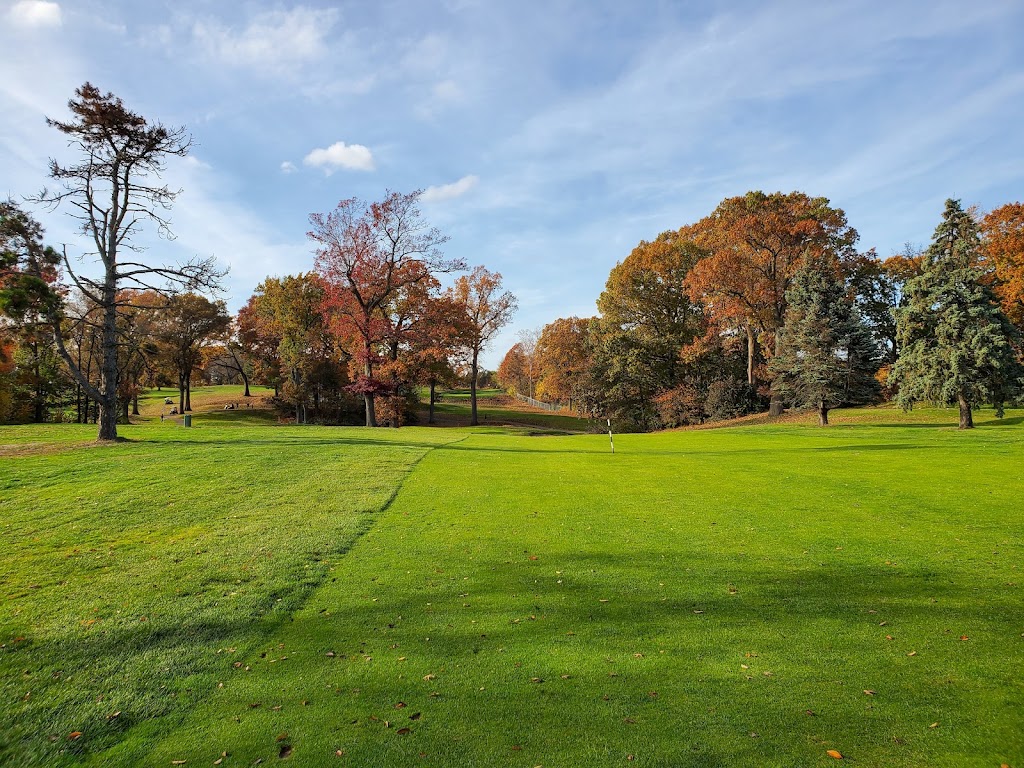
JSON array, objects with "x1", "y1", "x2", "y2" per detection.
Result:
[{"x1": 450, "y1": 266, "x2": 517, "y2": 427}]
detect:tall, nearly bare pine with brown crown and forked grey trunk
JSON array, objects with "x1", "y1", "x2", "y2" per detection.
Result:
[{"x1": 36, "y1": 83, "x2": 225, "y2": 440}]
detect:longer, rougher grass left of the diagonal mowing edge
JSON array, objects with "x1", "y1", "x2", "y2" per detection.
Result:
[{"x1": 0, "y1": 423, "x2": 452, "y2": 765}]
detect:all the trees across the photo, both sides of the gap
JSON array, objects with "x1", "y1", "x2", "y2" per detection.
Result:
[{"x1": 0, "y1": 83, "x2": 1024, "y2": 440}]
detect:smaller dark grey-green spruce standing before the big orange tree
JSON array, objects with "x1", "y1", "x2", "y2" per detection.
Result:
[{"x1": 769, "y1": 258, "x2": 879, "y2": 426}]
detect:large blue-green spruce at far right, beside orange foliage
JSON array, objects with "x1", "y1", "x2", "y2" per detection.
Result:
[{"x1": 893, "y1": 200, "x2": 1024, "y2": 429}]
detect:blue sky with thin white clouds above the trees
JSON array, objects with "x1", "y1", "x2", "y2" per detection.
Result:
[{"x1": 0, "y1": 0, "x2": 1024, "y2": 367}]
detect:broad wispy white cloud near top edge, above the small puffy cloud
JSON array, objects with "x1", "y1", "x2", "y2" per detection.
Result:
[{"x1": 193, "y1": 5, "x2": 338, "y2": 72}]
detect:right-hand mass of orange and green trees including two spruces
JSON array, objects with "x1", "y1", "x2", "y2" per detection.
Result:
[{"x1": 498, "y1": 191, "x2": 1024, "y2": 430}]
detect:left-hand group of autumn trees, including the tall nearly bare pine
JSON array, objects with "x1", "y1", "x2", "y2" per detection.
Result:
[{"x1": 0, "y1": 83, "x2": 516, "y2": 440}]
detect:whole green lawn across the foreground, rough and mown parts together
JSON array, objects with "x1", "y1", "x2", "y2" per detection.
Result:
[{"x1": 0, "y1": 412, "x2": 1024, "y2": 768}]
